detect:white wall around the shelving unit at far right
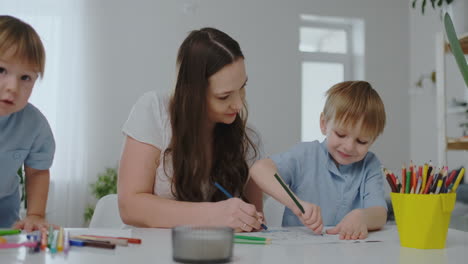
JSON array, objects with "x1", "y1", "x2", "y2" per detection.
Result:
[{"x1": 409, "y1": 0, "x2": 468, "y2": 168}]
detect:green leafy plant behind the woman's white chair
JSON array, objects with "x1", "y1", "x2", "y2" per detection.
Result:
[{"x1": 84, "y1": 168, "x2": 117, "y2": 222}]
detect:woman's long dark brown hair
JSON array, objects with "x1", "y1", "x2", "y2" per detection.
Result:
[{"x1": 163, "y1": 28, "x2": 258, "y2": 202}]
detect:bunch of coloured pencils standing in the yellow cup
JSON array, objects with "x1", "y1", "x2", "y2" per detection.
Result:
[{"x1": 383, "y1": 161, "x2": 465, "y2": 194}]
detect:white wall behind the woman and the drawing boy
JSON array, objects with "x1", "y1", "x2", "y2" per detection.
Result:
[{"x1": 0, "y1": 0, "x2": 412, "y2": 225}]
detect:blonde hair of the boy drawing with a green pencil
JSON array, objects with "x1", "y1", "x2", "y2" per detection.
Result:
[{"x1": 323, "y1": 81, "x2": 386, "y2": 140}]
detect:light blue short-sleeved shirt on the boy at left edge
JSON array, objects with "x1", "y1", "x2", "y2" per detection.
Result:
[{"x1": 0, "y1": 104, "x2": 55, "y2": 227}]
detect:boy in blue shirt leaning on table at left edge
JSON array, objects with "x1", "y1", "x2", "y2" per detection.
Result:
[{"x1": 0, "y1": 16, "x2": 55, "y2": 231}]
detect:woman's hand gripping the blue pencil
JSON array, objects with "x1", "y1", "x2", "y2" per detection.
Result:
[{"x1": 212, "y1": 198, "x2": 263, "y2": 232}]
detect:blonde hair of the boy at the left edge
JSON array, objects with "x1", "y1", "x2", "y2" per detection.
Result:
[{"x1": 0, "y1": 16, "x2": 45, "y2": 76}]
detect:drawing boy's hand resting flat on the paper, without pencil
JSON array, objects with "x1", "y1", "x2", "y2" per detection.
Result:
[{"x1": 327, "y1": 209, "x2": 368, "y2": 240}]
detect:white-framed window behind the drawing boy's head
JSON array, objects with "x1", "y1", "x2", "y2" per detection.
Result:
[{"x1": 299, "y1": 15, "x2": 364, "y2": 141}]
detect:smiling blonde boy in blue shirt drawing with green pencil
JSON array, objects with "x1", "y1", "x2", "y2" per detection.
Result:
[{"x1": 250, "y1": 81, "x2": 387, "y2": 239}]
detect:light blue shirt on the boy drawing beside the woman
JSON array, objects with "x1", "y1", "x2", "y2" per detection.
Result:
[{"x1": 270, "y1": 140, "x2": 387, "y2": 226}]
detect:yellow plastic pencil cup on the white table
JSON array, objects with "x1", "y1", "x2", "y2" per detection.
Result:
[{"x1": 390, "y1": 193, "x2": 456, "y2": 249}]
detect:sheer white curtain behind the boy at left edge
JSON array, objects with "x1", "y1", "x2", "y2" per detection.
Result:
[{"x1": 4, "y1": 1, "x2": 89, "y2": 227}]
